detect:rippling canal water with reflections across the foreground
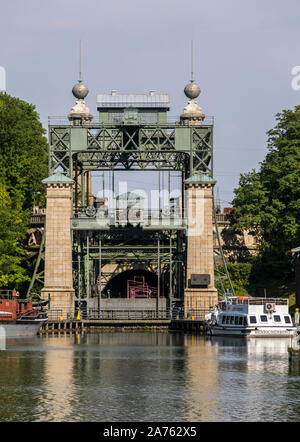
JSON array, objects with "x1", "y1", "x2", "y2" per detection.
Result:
[{"x1": 0, "y1": 331, "x2": 300, "y2": 422}]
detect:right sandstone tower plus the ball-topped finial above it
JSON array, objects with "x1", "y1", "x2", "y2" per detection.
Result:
[{"x1": 180, "y1": 79, "x2": 218, "y2": 317}]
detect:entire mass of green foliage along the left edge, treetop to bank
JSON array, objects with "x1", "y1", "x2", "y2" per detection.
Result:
[{"x1": 0, "y1": 93, "x2": 48, "y2": 288}]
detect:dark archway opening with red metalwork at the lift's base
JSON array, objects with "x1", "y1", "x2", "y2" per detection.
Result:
[{"x1": 103, "y1": 270, "x2": 167, "y2": 299}]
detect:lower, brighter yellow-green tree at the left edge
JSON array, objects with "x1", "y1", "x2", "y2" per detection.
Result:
[{"x1": 0, "y1": 185, "x2": 29, "y2": 289}]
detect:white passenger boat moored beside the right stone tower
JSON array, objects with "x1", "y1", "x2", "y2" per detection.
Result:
[{"x1": 205, "y1": 296, "x2": 297, "y2": 338}]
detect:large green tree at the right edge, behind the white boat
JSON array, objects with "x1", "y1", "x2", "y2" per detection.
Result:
[{"x1": 233, "y1": 106, "x2": 300, "y2": 294}]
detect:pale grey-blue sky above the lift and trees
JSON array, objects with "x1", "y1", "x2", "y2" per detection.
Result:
[{"x1": 0, "y1": 0, "x2": 300, "y2": 207}]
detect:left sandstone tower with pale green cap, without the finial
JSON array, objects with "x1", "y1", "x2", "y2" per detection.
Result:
[{"x1": 41, "y1": 172, "x2": 74, "y2": 319}]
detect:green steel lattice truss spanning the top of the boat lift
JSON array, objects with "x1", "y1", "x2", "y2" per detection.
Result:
[{"x1": 49, "y1": 124, "x2": 213, "y2": 177}]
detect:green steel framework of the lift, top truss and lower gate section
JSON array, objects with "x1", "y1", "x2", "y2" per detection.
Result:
[{"x1": 30, "y1": 117, "x2": 234, "y2": 310}]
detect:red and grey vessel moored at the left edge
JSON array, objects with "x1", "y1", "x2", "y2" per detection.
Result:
[{"x1": 0, "y1": 296, "x2": 48, "y2": 338}]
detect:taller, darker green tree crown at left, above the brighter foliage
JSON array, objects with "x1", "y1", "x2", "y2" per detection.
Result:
[{"x1": 0, "y1": 93, "x2": 48, "y2": 210}]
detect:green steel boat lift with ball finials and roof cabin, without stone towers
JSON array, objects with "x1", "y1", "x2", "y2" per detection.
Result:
[{"x1": 28, "y1": 80, "x2": 233, "y2": 318}]
